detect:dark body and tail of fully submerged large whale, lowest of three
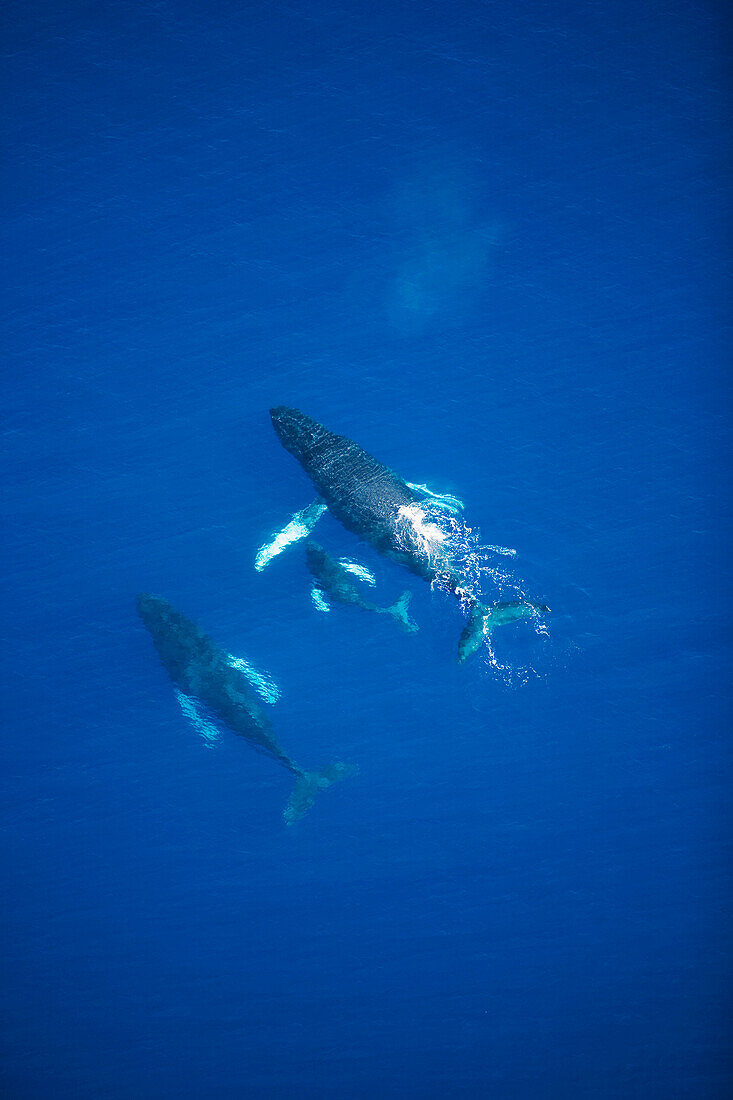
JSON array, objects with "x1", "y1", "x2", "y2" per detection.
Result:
[{"x1": 138, "y1": 593, "x2": 352, "y2": 825}]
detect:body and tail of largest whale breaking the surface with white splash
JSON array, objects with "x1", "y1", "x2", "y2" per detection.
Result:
[{"x1": 270, "y1": 405, "x2": 548, "y2": 663}]
